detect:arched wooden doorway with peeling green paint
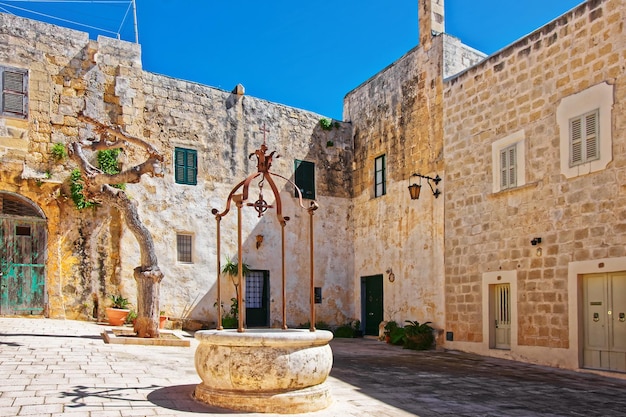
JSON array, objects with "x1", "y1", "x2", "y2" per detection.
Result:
[{"x1": 0, "y1": 192, "x2": 47, "y2": 315}]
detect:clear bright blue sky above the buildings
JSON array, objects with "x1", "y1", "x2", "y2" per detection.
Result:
[{"x1": 0, "y1": 0, "x2": 582, "y2": 119}]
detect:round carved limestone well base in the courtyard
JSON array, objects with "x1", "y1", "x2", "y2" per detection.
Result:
[{"x1": 194, "y1": 329, "x2": 333, "y2": 414}]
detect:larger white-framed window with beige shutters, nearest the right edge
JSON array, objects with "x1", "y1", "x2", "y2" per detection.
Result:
[{"x1": 556, "y1": 82, "x2": 614, "y2": 178}]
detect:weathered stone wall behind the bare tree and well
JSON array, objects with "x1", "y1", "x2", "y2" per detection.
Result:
[{"x1": 0, "y1": 14, "x2": 354, "y2": 325}]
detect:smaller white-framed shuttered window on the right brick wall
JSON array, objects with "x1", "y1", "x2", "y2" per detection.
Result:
[{"x1": 491, "y1": 130, "x2": 526, "y2": 193}]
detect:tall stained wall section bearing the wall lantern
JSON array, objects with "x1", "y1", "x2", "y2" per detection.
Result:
[{"x1": 344, "y1": 31, "x2": 445, "y2": 327}]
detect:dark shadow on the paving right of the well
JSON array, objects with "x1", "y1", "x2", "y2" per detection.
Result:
[{"x1": 331, "y1": 339, "x2": 626, "y2": 417}]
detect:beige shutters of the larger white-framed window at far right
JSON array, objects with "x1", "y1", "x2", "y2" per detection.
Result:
[{"x1": 569, "y1": 109, "x2": 600, "y2": 167}]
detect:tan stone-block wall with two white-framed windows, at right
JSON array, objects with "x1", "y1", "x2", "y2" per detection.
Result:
[{"x1": 443, "y1": 0, "x2": 626, "y2": 367}]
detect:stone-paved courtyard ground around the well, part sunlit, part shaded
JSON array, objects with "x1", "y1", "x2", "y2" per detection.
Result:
[{"x1": 0, "y1": 318, "x2": 626, "y2": 417}]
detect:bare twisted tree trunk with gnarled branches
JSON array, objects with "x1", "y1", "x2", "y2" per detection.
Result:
[{"x1": 69, "y1": 115, "x2": 163, "y2": 337}]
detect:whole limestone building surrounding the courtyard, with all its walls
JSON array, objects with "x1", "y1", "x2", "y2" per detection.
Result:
[{"x1": 0, "y1": 0, "x2": 626, "y2": 372}]
